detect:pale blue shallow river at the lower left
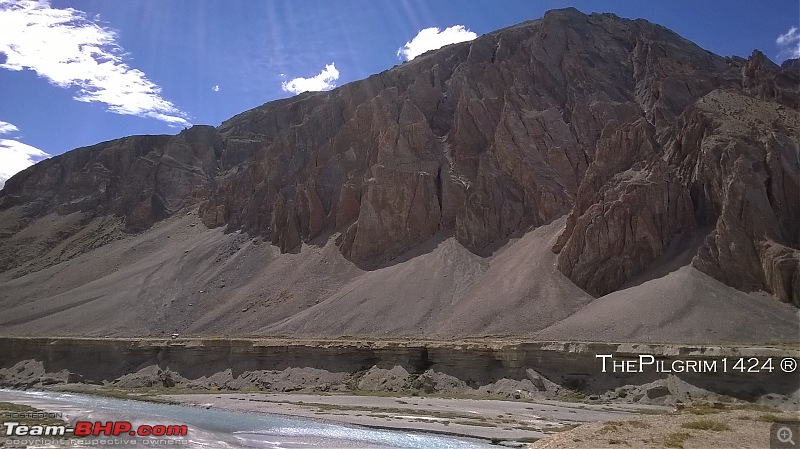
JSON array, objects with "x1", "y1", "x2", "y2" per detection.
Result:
[{"x1": 0, "y1": 389, "x2": 496, "y2": 449}]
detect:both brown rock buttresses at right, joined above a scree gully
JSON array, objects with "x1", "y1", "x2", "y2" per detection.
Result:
[{"x1": 554, "y1": 52, "x2": 800, "y2": 306}]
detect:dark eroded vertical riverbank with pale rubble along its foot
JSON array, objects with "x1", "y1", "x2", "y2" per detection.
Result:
[{"x1": 0, "y1": 337, "x2": 800, "y2": 409}]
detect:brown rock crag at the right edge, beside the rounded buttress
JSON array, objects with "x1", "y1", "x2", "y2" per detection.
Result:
[{"x1": 666, "y1": 91, "x2": 800, "y2": 306}]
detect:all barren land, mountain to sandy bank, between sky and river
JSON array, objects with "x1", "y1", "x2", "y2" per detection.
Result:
[{"x1": 0, "y1": 8, "x2": 800, "y2": 449}]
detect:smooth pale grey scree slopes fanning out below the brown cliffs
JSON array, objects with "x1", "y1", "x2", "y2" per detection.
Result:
[{"x1": 0, "y1": 212, "x2": 800, "y2": 343}]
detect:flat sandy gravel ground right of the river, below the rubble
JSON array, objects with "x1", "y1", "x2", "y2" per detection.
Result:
[{"x1": 157, "y1": 393, "x2": 800, "y2": 449}]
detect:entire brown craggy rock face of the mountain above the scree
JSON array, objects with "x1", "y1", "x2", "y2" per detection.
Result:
[{"x1": 0, "y1": 9, "x2": 800, "y2": 305}]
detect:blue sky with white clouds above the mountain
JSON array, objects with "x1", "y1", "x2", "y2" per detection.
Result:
[{"x1": 0, "y1": 0, "x2": 800, "y2": 183}]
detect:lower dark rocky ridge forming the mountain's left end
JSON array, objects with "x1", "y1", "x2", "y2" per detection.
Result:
[{"x1": 0, "y1": 126, "x2": 221, "y2": 276}]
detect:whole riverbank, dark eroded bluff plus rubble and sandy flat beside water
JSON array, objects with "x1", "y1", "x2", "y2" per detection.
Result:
[{"x1": 0, "y1": 338, "x2": 800, "y2": 449}]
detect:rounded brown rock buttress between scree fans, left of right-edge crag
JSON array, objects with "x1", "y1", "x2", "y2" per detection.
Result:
[{"x1": 554, "y1": 119, "x2": 695, "y2": 296}]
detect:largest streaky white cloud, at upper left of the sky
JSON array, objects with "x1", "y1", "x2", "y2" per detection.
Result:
[{"x1": 0, "y1": 0, "x2": 189, "y2": 126}]
